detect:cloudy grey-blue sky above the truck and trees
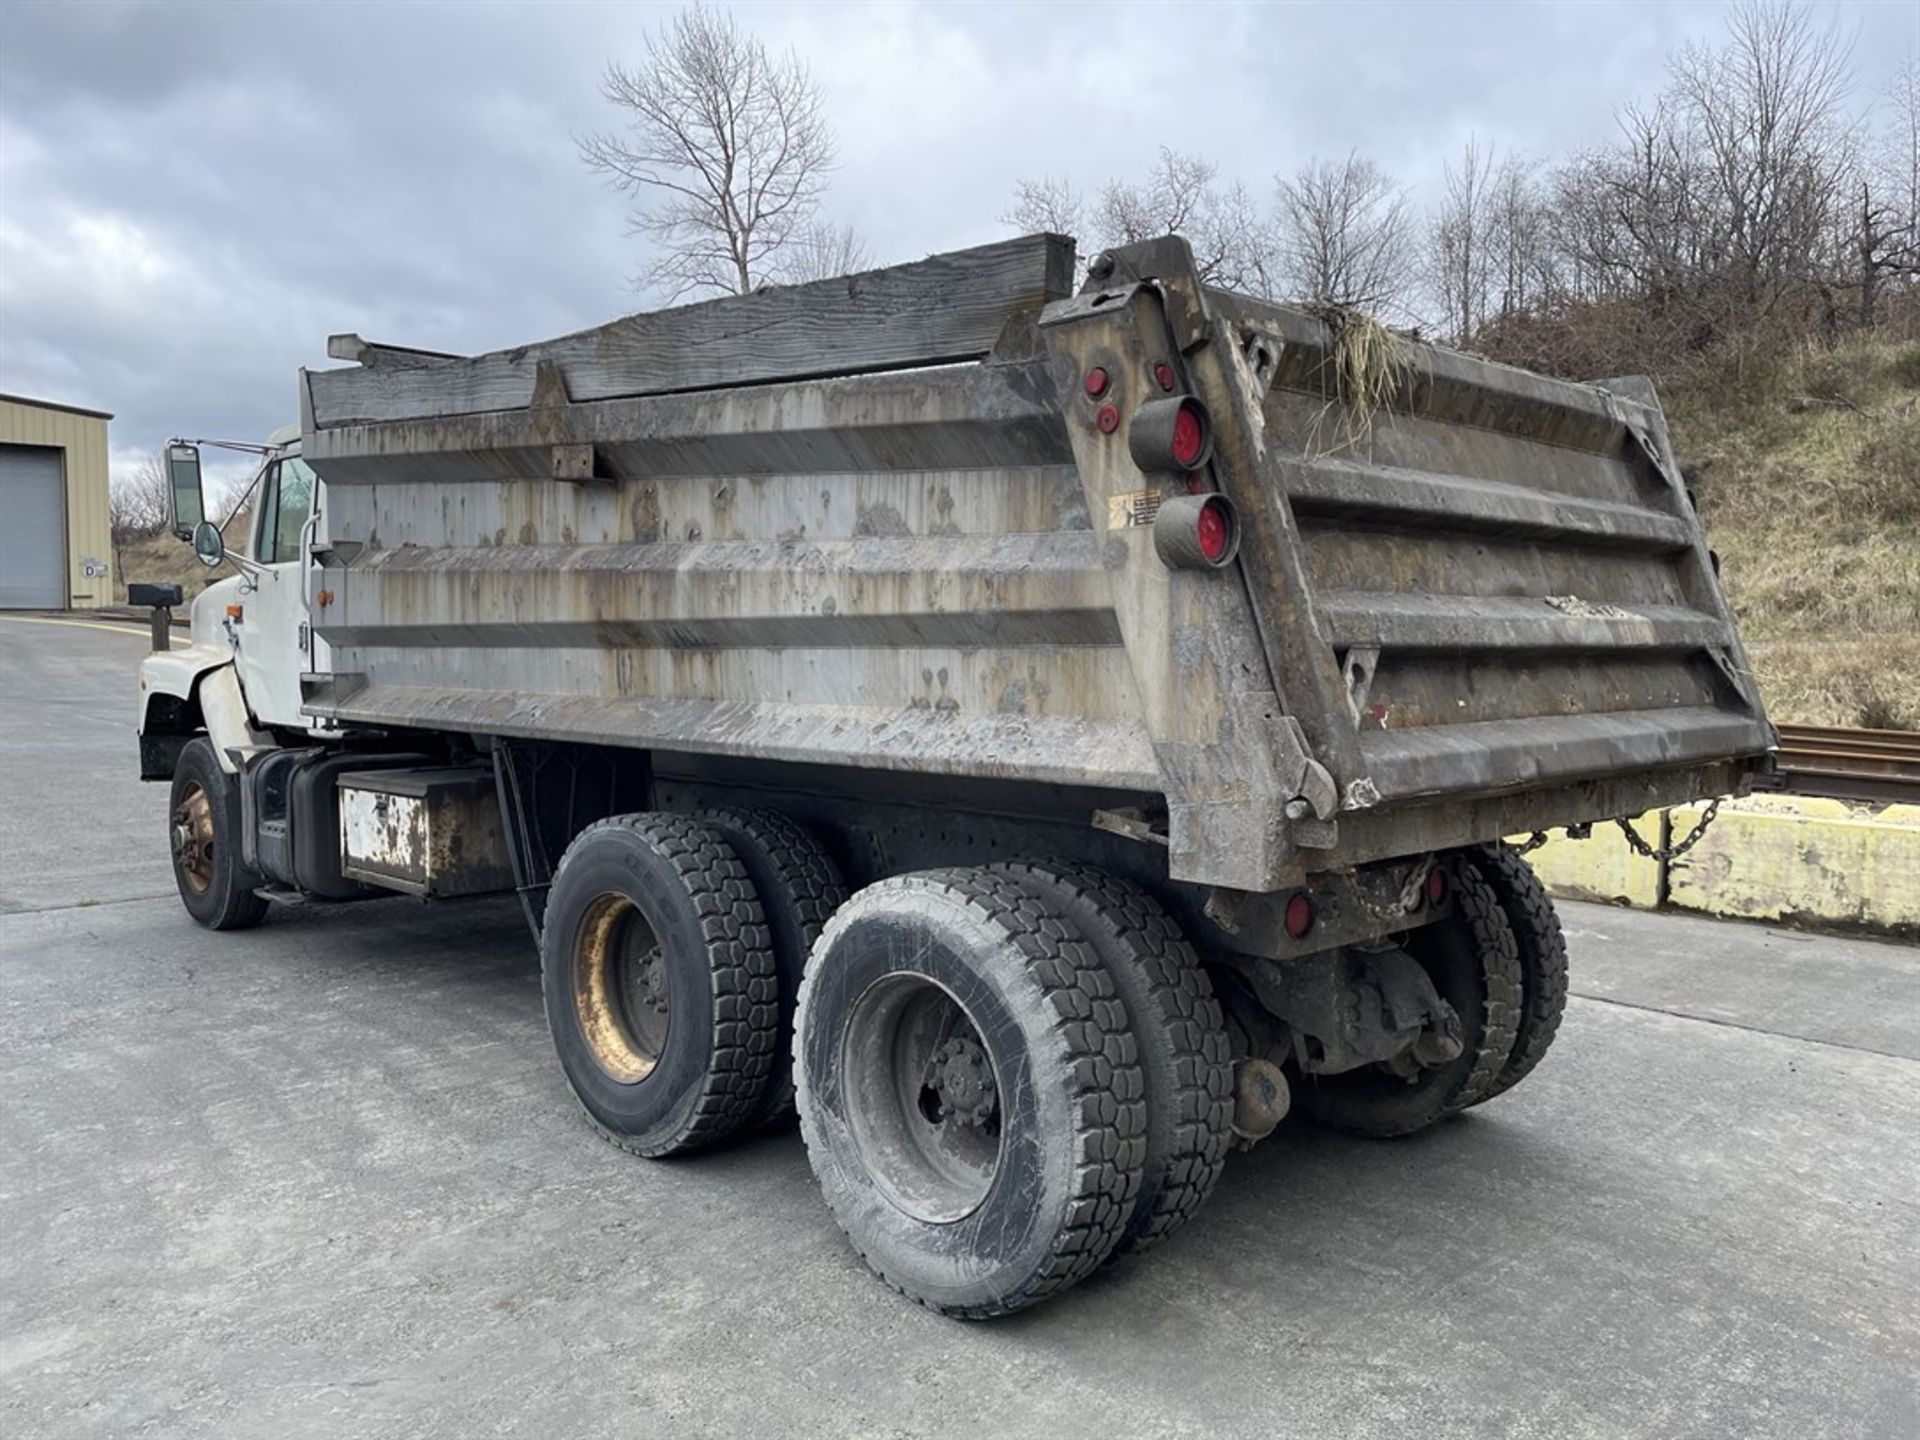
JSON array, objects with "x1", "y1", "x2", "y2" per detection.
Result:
[{"x1": 0, "y1": 0, "x2": 1920, "y2": 491}]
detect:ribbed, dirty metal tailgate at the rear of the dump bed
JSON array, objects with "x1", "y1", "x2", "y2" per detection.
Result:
[{"x1": 1208, "y1": 292, "x2": 1772, "y2": 820}]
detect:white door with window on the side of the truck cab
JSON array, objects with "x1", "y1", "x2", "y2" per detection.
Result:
[{"x1": 228, "y1": 455, "x2": 319, "y2": 730}]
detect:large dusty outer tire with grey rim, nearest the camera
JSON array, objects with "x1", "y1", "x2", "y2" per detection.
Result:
[{"x1": 795, "y1": 870, "x2": 1146, "y2": 1319}]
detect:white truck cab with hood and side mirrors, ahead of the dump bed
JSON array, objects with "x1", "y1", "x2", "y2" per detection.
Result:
[{"x1": 138, "y1": 426, "x2": 330, "y2": 778}]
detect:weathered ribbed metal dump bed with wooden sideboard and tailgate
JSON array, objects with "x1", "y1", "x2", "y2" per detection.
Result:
[{"x1": 301, "y1": 236, "x2": 1770, "y2": 889}]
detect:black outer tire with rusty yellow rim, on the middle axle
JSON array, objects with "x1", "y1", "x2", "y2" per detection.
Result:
[{"x1": 540, "y1": 814, "x2": 780, "y2": 1158}]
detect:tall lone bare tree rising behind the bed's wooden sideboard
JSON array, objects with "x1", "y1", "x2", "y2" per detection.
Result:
[{"x1": 578, "y1": 6, "x2": 833, "y2": 300}]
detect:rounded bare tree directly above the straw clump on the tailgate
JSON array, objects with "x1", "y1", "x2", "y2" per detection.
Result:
[{"x1": 1277, "y1": 152, "x2": 1413, "y2": 311}]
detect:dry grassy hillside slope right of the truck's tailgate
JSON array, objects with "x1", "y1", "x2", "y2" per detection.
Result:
[{"x1": 1663, "y1": 338, "x2": 1920, "y2": 730}]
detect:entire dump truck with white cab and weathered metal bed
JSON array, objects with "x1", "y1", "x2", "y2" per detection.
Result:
[{"x1": 140, "y1": 234, "x2": 1774, "y2": 1317}]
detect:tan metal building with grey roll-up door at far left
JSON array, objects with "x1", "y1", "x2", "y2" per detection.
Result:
[{"x1": 0, "y1": 396, "x2": 115, "y2": 611}]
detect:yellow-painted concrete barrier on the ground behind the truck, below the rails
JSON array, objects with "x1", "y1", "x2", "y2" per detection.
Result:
[{"x1": 1515, "y1": 795, "x2": 1920, "y2": 937}]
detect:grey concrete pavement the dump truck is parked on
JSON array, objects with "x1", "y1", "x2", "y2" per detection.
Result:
[{"x1": 0, "y1": 618, "x2": 1920, "y2": 1440}]
